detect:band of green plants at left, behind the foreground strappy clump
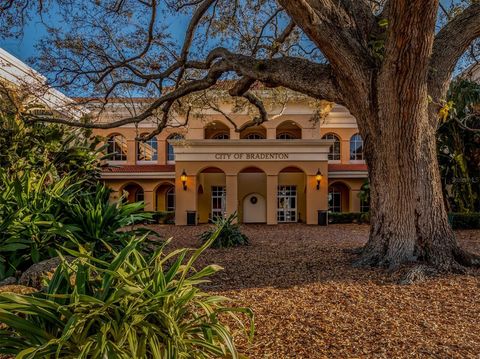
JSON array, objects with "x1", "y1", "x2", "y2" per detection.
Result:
[{"x1": 0, "y1": 168, "x2": 151, "y2": 279}]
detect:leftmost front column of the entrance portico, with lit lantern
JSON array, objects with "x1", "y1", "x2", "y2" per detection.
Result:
[{"x1": 175, "y1": 166, "x2": 198, "y2": 226}]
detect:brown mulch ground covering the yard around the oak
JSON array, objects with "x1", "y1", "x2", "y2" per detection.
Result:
[{"x1": 151, "y1": 224, "x2": 480, "y2": 359}]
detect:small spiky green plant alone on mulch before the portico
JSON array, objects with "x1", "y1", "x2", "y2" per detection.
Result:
[{"x1": 199, "y1": 213, "x2": 248, "y2": 248}]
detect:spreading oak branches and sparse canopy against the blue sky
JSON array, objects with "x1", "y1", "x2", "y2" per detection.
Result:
[{"x1": 0, "y1": 0, "x2": 480, "y2": 139}]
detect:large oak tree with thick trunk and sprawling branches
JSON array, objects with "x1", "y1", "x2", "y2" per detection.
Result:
[{"x1": 0, "y1": 0, "x2": 480, "y2": 270}]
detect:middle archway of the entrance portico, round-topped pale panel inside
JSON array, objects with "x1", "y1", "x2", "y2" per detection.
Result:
[{"x1": 238, "y1": 167, "x2": 267, "y2": 223}]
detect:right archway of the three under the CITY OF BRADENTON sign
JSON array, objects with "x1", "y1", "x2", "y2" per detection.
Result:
[{"x1": 277, "y1": 167, "x2": 306, "y2": 223}]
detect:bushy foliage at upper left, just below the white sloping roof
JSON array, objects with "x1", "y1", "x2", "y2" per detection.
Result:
[{"x1": 0, "y1": 87, "x2": 104, "y2": 186}]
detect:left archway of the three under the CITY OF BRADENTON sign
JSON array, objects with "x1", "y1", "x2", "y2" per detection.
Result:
[{"x1": 197, "y1": 167, "x2": 227, "y2": 223}]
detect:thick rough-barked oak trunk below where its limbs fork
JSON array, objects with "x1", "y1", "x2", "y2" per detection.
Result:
[{"x1": 361, "y1": 108, "x2": 457, "y2": 270}]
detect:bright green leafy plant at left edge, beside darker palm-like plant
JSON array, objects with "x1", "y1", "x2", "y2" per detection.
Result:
[{"x1": 0, "y1": 169, "x2": 81, "y2": 278}]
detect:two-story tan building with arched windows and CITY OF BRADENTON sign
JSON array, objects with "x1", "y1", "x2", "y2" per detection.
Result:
[{"x1": 91, "y1": 89, "x2": 368, "y2": 225}]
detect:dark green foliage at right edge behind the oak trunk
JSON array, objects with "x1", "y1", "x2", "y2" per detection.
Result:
[{"x1": 437, "y1": 80, "x2": 480, "y2": 212}]
